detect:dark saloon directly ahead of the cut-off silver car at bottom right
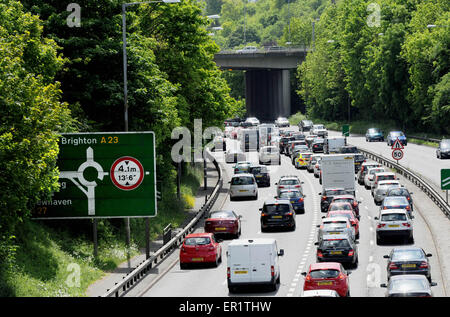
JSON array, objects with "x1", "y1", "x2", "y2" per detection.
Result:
[{"x1": 383, "y1": 247, "x2": 432, "y2": 282}]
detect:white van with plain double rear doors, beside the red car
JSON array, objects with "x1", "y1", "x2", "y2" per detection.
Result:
[{"x1": 227, "y1": 238, "x2": 284, "y2": 293}]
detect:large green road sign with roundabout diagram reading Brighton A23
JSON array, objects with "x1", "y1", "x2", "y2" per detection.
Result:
[{"x1": 33, "y1": 132, "x2": 157, "y2": 219}]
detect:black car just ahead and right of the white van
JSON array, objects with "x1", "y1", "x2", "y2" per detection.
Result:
[{"x1": 259, "y1": 195, "x2": 296, "y2": 232}]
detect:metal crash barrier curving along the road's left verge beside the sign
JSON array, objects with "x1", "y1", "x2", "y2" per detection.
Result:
[{"x1": 102, "y1": 150, "x2": 223, "y2": 297}]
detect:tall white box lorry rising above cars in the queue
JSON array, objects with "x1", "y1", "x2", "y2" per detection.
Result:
[{"x1": 320, "y1": 154, "x2": 355, "y2": 195}]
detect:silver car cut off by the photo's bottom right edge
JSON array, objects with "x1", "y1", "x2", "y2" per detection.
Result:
[{"x1": 380, "y1": 274, "x2": 437, "y2": 297}]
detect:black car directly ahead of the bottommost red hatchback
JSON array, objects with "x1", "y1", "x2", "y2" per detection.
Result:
[{"x1": 315, "y1": 233, "x2": 358, "y2": 268}]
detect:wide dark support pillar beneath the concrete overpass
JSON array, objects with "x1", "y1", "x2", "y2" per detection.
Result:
[{"x1": 245, "y1": 69, "x2": 291, "y2": 122}]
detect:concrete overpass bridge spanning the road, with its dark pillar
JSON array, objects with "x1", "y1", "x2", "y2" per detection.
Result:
[{"x1": 214, "y1": 48, "x2": 309, "y2": 121}]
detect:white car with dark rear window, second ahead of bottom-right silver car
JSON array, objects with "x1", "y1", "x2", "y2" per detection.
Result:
[{"x1": 374, "y1": 209, "x2": 414, "y2": 244}]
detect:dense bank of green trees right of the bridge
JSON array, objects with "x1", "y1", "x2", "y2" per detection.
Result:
[{"x1": 298, "y1": 0, "x2": 450, "y2": 134}]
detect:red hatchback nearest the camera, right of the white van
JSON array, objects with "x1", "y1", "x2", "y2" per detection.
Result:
[{"x1": 302, "y1": 262, "x2": 351, "y2": 297}]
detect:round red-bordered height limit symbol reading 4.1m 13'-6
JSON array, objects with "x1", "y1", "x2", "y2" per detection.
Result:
[{"x1": 110, "y1": 156, "x2": 144, "y2": 190}]
